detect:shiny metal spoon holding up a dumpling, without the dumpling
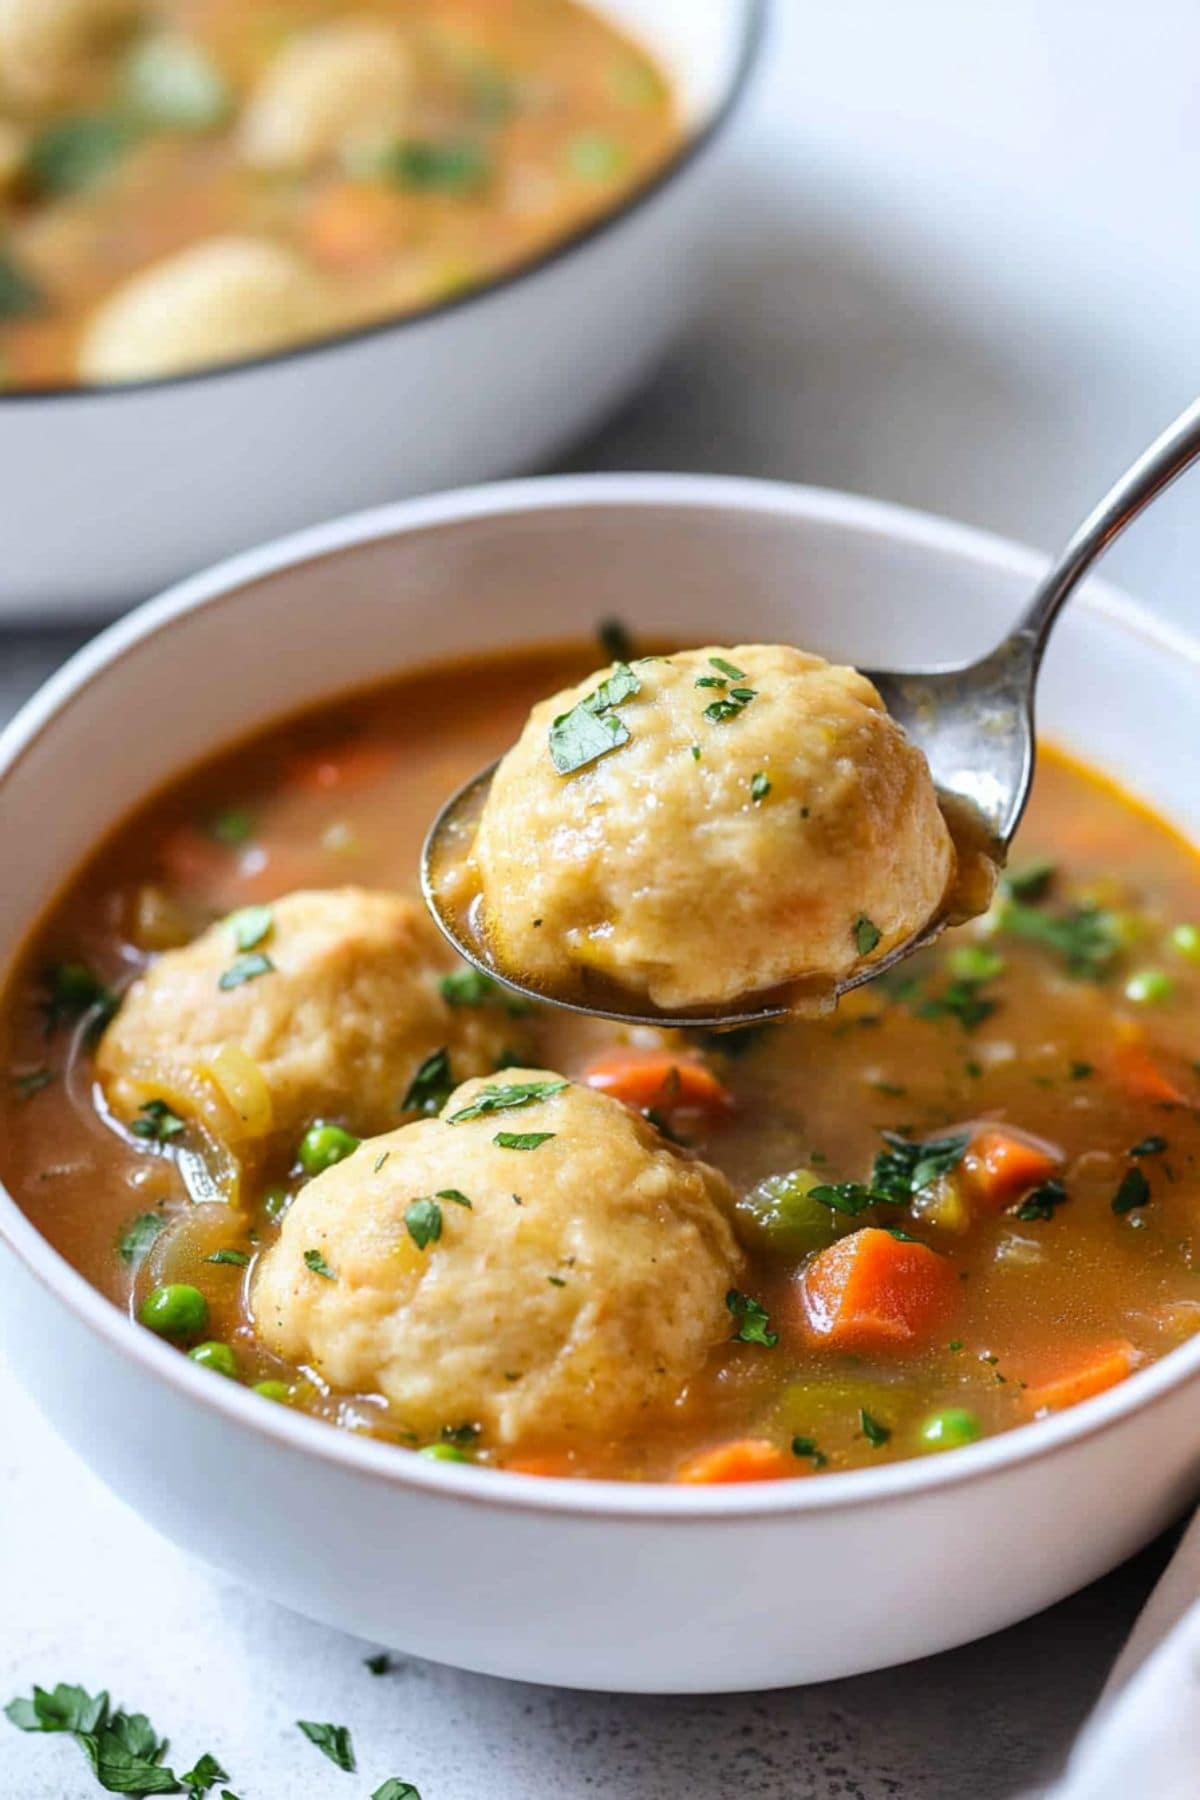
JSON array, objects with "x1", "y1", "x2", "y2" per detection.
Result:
[{"x1": 421, "y1": 400, "x2": 1200, "y2": 1030}]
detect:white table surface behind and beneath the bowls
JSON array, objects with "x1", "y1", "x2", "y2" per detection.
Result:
[{"x1": 0, "y1": 0, "x2": 1200, "y2": 1800}]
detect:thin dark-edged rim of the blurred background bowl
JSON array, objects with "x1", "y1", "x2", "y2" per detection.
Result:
[{"x1": 0, "y1": 0, "x2": 772, "y2": 418}]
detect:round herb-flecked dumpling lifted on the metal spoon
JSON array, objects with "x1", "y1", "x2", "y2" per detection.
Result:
[{"x1": 450, "y1": 644, "x2": 955, "y2": 1012}]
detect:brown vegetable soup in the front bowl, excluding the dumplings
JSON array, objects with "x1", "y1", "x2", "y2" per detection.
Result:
[{"x1": 0, "y1": 646, "x2": 1200, "y2": 1481}]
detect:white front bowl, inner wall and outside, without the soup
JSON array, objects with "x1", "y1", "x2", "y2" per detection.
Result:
[{"x1": 0, "y1": 475, "x2": 1200, "y2": 1692}]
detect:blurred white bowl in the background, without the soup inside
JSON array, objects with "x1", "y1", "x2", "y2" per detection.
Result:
[{"x1": 0, "y1": 0, "x2": 766, "y2": 621}]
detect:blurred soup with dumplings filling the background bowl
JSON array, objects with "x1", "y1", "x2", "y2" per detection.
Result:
[{"x1": 0, "y1": 0, "x2": 678, "y2": 389}]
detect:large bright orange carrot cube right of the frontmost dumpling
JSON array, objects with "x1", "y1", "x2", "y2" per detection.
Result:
[{"x1": 799, "y1": 1226, "x2": 957, "y2": 1350}]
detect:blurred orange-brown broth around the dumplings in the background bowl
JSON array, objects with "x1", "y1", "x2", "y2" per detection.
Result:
[{"x1": 0, "y1": 0, "x2": 680, "y2": 389}]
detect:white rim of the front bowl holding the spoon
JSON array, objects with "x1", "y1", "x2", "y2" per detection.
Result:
[{"x1": 0, "y1": 473, "x2": 1200, "y2": 1526}]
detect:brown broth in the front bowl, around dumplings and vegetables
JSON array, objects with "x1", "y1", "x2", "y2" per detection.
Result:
[{"x1": 0, "y1": 646, "x2": 1200, "y2": 1480}]
